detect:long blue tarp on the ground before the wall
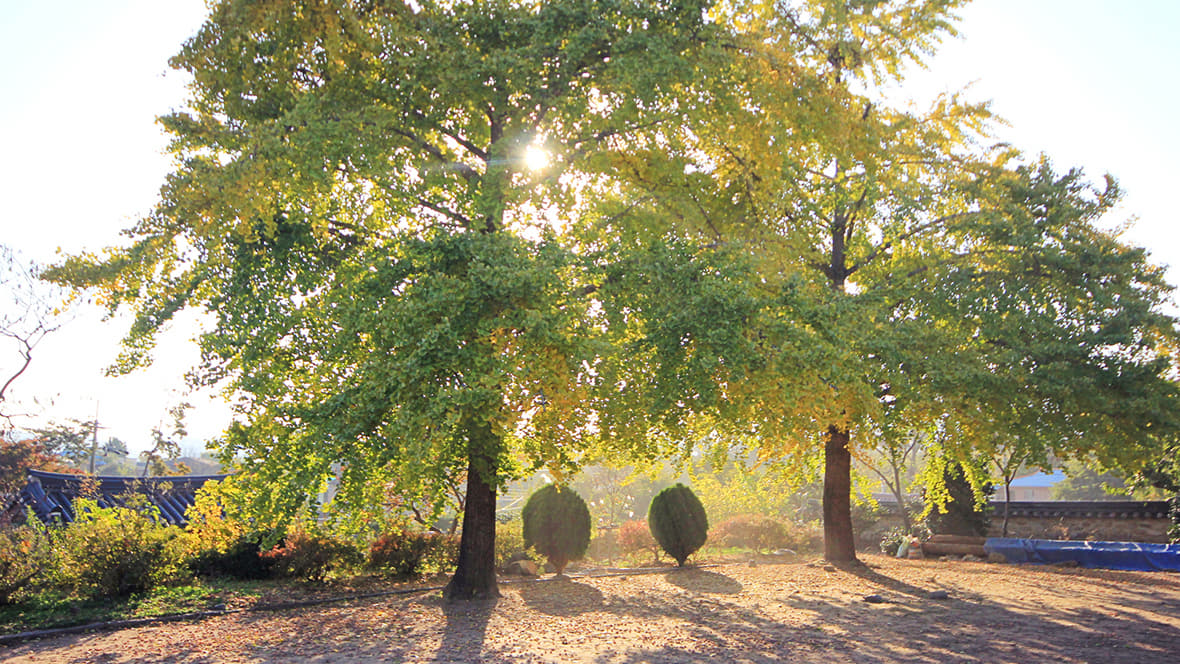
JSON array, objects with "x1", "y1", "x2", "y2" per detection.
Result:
[{"x1": 983, "y1": 538, "x2": 1180, "y2": 572}]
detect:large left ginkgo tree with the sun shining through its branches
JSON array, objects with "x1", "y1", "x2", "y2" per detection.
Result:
[{"x1": 54, "y1": 0, "x2": 745, "y2": 598}]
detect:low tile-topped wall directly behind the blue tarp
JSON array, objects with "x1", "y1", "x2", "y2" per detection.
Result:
[{"x1": 988, "y1": 500, "x2": 1172, "y2": 544}]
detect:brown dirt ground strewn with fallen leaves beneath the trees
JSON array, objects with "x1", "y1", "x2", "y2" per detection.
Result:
[{"x1": 0, "y1": 555, "x2": 1180, "y2": 664}]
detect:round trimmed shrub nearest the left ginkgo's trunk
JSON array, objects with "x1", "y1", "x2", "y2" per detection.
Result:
[{"x1": 520, "y1": 485, "x2": 590, "y2": 574}]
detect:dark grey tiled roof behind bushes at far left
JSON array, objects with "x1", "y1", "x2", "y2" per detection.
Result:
[{"x1": 20, "y1": 471, "x2": 227, "y2": 526}]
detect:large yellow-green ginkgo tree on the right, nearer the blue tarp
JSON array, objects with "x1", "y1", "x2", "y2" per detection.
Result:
[{"x1": 599, "y1": 0, "x2": 1180, "y2": 561}]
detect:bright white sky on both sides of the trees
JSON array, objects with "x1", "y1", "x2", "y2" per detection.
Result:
[{"x1": 0, "y1": 0, "x2": 1180, "y2": 451}]
